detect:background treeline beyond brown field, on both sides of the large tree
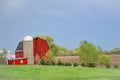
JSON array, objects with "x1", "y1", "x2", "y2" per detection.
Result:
[{"x1": 42, "y1": 35, "x2": 120, "y2": 56}]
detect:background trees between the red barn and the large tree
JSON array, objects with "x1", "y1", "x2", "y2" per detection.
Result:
[{"x1": 42, "y1": 35, "x2": 79, "y2": 56}]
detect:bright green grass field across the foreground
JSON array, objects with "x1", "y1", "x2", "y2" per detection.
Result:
[{"x1": 0, "y1": 65, "x2": 120, "y2": 80}]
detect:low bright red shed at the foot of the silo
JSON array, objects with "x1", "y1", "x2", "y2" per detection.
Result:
[{"x1": 8, "y1": 58, "x2": 28, "y2": 65}]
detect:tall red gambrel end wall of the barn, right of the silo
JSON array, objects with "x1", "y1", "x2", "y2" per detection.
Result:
[{"x1": 33, "y1": 37, "x2": 50, "y2": 64}]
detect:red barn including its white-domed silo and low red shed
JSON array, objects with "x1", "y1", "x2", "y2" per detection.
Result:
[{"x1": 8, "y1": 36, "x2": 50, "y2": 65}]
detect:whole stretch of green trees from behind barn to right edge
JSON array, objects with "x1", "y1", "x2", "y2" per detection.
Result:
[{"x1": 44, "y1": 35, "x2": 120, "y2": 68}]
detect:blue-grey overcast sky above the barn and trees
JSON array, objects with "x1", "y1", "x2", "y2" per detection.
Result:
[{"x1": 0, "y1": 0, "x2": 120, "y2": 52}]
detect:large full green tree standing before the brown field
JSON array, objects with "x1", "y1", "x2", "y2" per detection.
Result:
[{"x1": 79, "y1": 41, "x2": 99, "y2": 66}]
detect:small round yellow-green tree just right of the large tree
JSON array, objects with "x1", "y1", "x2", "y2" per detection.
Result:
[{"x1": 99, "y1": 54, "x2": 112, "y2": 67}]
